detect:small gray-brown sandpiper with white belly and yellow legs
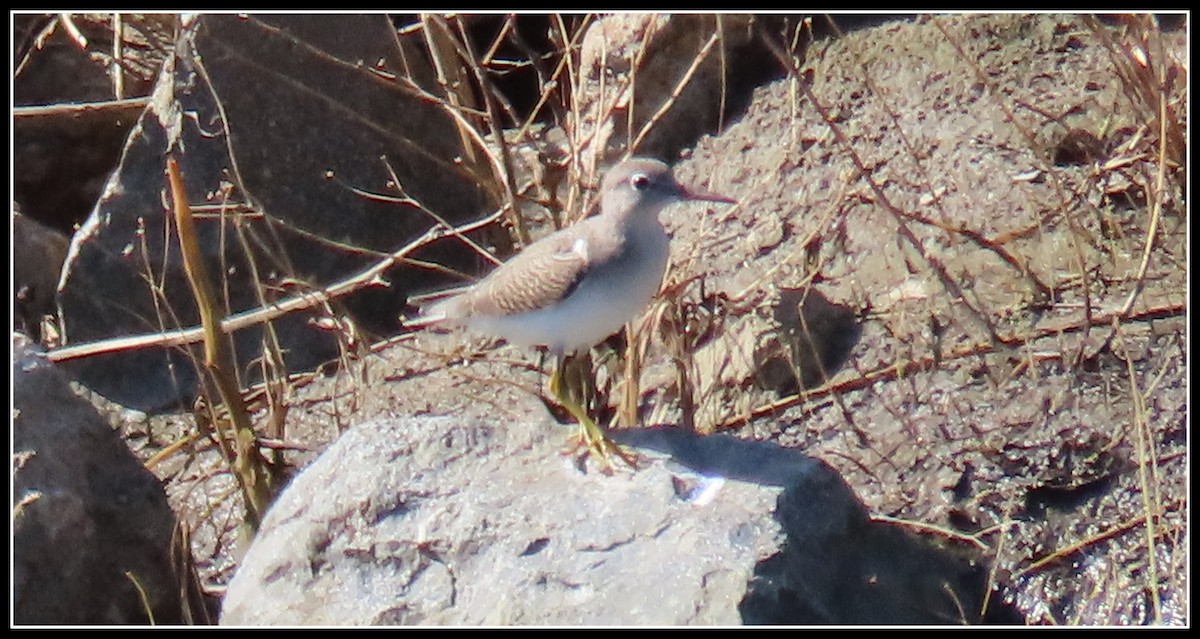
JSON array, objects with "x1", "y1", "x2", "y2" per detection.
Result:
[{"x1": 425, "y1": 157, "x2": 736, "y2": 459}]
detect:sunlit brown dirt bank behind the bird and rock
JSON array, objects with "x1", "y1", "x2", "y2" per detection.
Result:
[{"x1": 70, "y1": 16, "x2": 1188, "y2": 625}]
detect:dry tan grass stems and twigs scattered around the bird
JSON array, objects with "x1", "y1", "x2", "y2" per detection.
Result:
[{"x1": 23, "y1": 14, "x2": 1187, "y2": 622}]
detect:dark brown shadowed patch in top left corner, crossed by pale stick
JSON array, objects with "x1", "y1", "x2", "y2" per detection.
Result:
[{"x1": 12, "y1": 13, "x2": 176, "y2": 231}]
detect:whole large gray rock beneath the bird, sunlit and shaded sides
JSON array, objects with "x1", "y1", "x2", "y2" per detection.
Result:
[{"x1": 221, "y1": 417, "x2": 978, "y2": 625}]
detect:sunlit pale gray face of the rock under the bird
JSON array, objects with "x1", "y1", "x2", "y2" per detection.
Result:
[{"x1": 222, "y1": 418, "x2": 778, "y2": 625}]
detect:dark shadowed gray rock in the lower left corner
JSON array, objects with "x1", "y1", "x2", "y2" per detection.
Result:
[{"x1": 12, "y1": 335, "x2": 181, "y2": 625}]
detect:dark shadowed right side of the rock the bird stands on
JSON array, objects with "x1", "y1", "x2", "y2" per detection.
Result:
[{"x1": 612, "y1": 428, "x2": 1019, "y2": 625}]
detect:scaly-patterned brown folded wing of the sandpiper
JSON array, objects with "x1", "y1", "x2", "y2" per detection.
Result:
[{"x1": 462, "y1": 222, "x2": 620, "y2": 316}]
